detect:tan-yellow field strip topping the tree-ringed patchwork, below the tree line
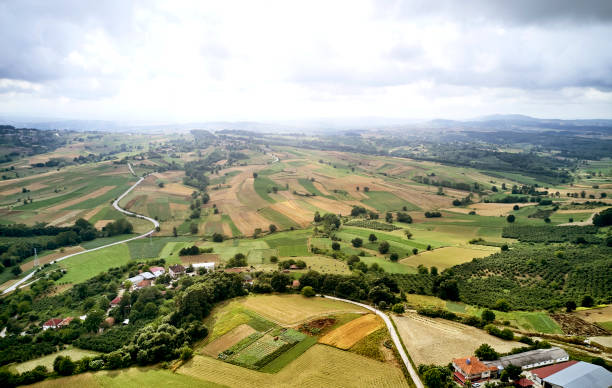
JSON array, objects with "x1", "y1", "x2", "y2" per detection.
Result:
[{"x1": 241, "y1": 295, "x2": 366, "y2": 325}]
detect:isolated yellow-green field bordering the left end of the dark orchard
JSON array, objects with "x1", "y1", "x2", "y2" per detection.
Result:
[{"x1": 400, "y1": 245, "x2": 499, "y2": 269}]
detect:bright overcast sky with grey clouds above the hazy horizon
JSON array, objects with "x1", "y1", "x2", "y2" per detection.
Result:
[{"x1": 0, "y1": 0, "x2": 612, "y2": 122}]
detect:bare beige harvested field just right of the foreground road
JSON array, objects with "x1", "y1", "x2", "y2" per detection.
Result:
[{"x1": 393, "y1": 313, "x2": 521, "y2": 365}]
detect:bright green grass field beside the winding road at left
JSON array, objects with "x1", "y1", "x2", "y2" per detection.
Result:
[{"x1": 58, "y1": 244, "x2": 130, "y2": 284}]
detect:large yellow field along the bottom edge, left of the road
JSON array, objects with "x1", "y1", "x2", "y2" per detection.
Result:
[{"x1": 177, "y1": 345, "x2": 408, "y2": 388}]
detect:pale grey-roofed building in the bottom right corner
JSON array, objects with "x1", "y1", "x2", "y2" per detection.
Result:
[{"x1": 542, "y1": 361, "x2": 612, "y2": 388}]
